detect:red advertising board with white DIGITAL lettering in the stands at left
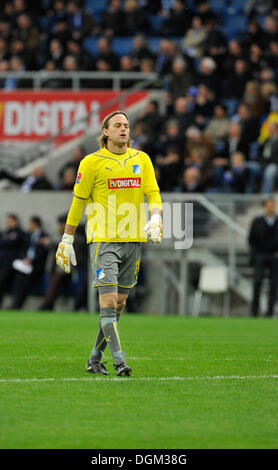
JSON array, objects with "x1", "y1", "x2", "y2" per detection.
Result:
[{"x1": 0, "y1": 91, "x2": 148, "y2": 141}]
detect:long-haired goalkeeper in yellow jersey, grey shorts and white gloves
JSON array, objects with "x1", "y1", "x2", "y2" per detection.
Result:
[{"x1": 56, "y1": 111, "x2": 162, "y2": 376}]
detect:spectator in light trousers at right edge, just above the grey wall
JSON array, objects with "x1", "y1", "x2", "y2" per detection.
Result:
[{"x1": 260, "y1": 122, "x2": 278, "y2": 194}]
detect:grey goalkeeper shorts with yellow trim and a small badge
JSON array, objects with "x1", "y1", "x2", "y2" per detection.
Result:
[{"x1": 90, "y1": 242, "x2": 140, "y2": 294}]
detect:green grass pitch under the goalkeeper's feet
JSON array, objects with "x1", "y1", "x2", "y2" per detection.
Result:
[{"x1": 0, "y1": 311, "x2": 278, "y2": 449}]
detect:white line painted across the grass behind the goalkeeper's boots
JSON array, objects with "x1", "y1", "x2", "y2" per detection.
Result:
[{"x1": 0, "y1": 374, "x2": 278, "y2": 383}]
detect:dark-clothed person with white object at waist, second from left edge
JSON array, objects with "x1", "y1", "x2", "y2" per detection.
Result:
[{"x1": 11, "y1": 216, "x2": 50, "y2": 309}]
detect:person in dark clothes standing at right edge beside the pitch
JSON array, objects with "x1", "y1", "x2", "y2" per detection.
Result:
[{"x1": 248, "y1": 197, "x2": 278, "y2": 317}]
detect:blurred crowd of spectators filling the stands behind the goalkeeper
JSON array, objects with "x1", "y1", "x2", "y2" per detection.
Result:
[{"x1": 0, "y1": 0, "x2": 278, "y2": 193}]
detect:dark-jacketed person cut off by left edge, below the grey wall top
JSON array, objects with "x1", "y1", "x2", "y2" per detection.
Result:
[{"x1": 0, "y1": 214, "x2": 25, "y2": 305}]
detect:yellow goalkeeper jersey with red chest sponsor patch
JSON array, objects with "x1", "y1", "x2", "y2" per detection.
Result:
[{"x1": 67, "y1": 148, "x2": 162, "y2": 243}]
